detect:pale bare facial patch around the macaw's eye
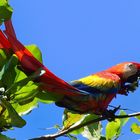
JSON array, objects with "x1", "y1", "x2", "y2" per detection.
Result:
[{"x1": 123, "y1": 63, "x2": 137, "y2": 79}]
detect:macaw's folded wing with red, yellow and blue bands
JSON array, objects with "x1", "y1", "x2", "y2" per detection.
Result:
[{"x1": 70, "y1": 71, "x2": 121, "y2": 94}]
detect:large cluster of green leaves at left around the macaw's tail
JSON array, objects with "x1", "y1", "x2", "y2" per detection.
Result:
[{"x1": 0, "y1": 45, "x2": 59, "y2": 131}]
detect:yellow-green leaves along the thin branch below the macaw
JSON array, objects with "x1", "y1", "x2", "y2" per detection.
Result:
[{"x1": 62, "y1": 109, "x2": 140, "y2": 140}]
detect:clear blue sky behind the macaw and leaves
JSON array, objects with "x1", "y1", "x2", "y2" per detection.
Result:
[{"x1": 2, "y1": 0, "x2": 140, "y2": 140}]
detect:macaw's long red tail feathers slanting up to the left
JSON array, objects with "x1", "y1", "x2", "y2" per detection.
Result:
[{"x1": 3, "y1": 21, "x2": 81, "y2": 96}]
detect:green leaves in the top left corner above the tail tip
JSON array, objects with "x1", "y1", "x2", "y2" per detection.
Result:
[{"x1": 0, "y1": 0, "x2": 13, "y2": 24}]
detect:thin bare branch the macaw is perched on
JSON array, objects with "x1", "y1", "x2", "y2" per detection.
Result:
[{"x1": 30, "y1": 112, "x2": 140, "y2": 140}]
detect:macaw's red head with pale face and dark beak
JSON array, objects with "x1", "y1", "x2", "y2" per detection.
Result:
[{"x1": 106, "y1": 62, "x2": 140, "y2": 83}]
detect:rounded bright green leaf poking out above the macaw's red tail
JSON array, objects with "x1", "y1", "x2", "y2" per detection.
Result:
[{"x1": 26, "y1": 44, "x2": 42, "y2": 63}]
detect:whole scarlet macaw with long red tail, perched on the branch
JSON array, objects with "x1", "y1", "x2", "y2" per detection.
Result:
[{"x1": 0, "y1": 21, "x2": 140, "y2": 114}]
